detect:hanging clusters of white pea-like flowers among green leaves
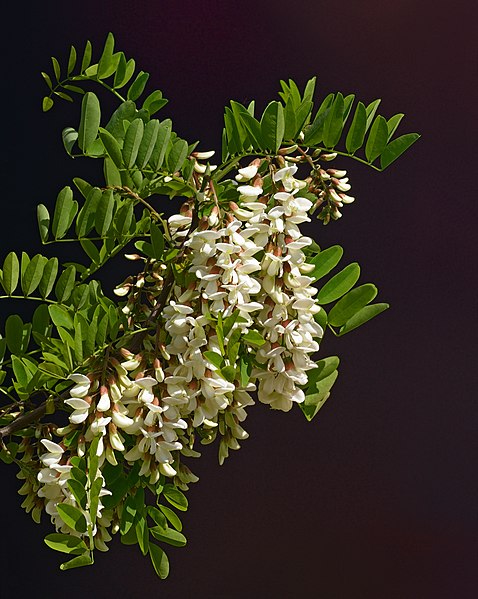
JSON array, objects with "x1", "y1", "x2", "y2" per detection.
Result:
[{"x1": 32, "y1": 162, "x2": 353, "y2": 550}]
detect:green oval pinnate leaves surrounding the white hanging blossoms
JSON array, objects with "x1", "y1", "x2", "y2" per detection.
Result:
[{"x1": 0, "y1": 33, "x2": 419, "y2": 578}]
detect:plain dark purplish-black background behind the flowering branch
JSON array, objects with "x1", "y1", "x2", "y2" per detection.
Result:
[{"x1": 0, "y1": 0, "x2": 478, "y2": 599}]
